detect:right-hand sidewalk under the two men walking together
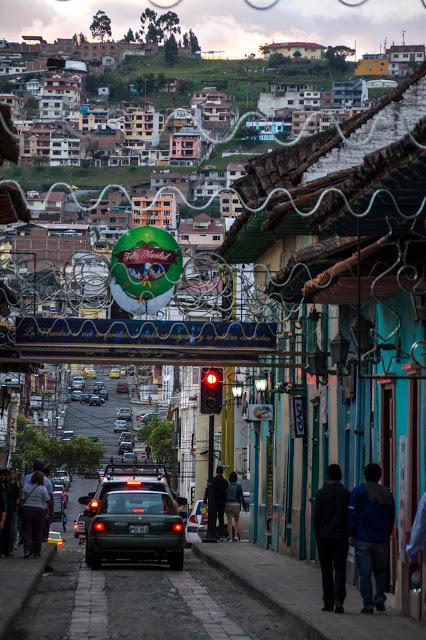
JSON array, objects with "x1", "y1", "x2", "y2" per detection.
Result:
[{"x1": 192, "y1": 543, "x2": 426, "y2": 640}]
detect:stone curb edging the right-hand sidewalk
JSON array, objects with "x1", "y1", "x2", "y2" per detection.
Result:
[{"x1": 192, "y1": 543, "x2": 335, "y2": 640}]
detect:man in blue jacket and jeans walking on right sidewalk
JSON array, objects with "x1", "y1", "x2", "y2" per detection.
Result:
[{"x1": 348, "y1": 463, "x2": 395, "y2": 614}]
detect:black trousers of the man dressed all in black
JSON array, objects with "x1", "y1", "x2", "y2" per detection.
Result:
[{"x1": 317, "y1": 539, "x2": 349, "y2": 609}]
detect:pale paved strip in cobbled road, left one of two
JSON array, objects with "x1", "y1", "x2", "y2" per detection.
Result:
[{"x1": 69, "y1": 560, "x2": 110, "y2": 640}]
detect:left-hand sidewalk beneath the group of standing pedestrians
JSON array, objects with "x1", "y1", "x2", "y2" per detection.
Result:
[{"x1": 0, "y1": 544, "x2": 56, "y2": 640}]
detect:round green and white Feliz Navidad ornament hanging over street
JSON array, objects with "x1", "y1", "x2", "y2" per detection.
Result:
[{"x1": 111, "y1": 227, "x2": 183, "y2": 315}]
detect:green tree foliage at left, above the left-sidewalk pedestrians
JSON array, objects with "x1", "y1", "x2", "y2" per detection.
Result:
[{"x1": 12, "y1": 416, "x2": 105, "y2": 472}]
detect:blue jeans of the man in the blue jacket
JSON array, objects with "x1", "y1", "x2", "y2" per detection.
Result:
[{"x1": 355, "y1": 540, "x2": 389, "y2": 609}]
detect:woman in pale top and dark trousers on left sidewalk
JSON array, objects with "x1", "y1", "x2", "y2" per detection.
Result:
[{"x1": 22, "y1": 471, "x2": 50, "y2": 558}]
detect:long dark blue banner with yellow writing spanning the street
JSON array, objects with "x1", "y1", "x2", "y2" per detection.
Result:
[{"x1": 15, "y1": 317, "x2": 277, "y2": 362}]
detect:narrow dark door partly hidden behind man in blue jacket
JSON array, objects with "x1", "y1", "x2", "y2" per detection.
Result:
[{"x1": 380, "y1": 384, "x2": 397, "y2": 593}]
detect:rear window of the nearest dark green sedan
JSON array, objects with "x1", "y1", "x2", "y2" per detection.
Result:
[{"x1": 101, "y1": 492, "x2": 177, "y2": 515}]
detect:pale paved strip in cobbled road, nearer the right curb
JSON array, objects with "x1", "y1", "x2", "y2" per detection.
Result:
[{"x1": 168, "y1": 571, "x2": 251, "y2": 640}]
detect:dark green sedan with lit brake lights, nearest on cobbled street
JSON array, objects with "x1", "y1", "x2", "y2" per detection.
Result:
[{"x1": 86, "y1": 491, "x2": 185, "y2": 571}]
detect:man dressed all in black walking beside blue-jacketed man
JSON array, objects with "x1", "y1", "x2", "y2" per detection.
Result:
[{"x1": 314, "y1": 464, "x2": 350, "y2": 613}]
